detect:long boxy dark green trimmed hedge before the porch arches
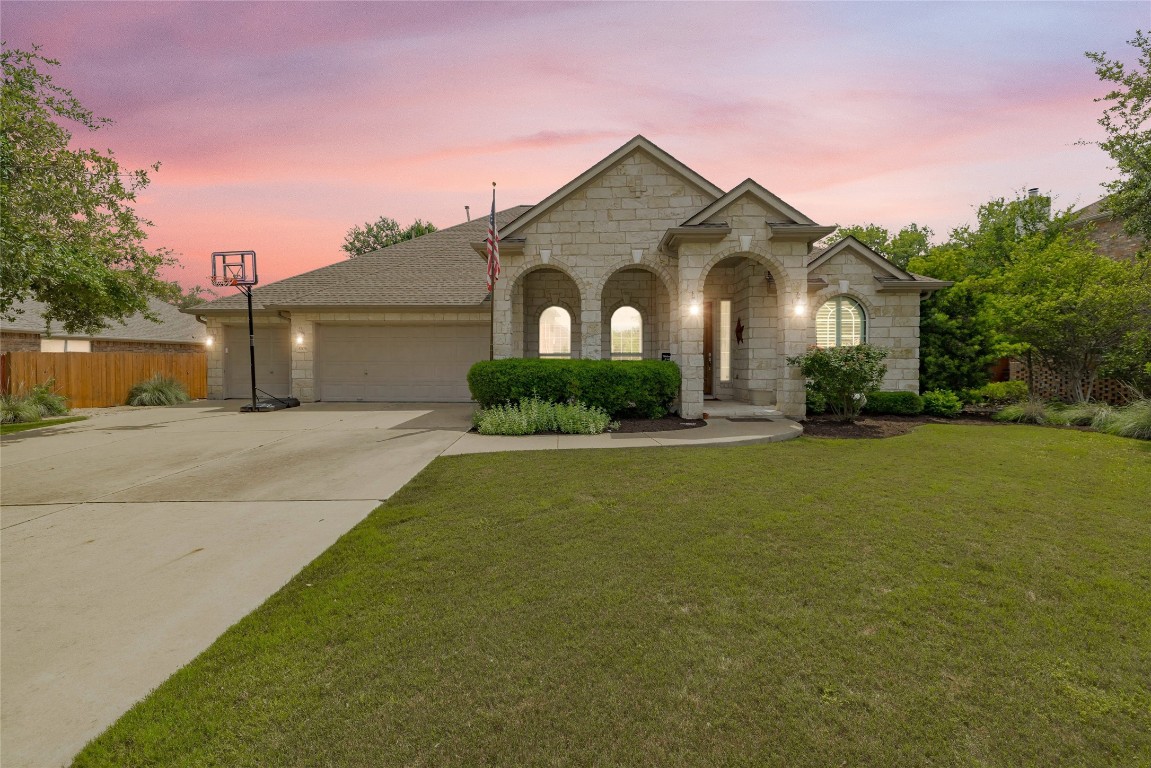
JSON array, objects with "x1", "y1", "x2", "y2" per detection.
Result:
[{"x1": 467, "y1": 358, "x2": 679, "y2": 418}]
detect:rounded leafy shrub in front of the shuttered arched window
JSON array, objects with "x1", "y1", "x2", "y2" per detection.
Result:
[{"x1": 787, "y1": 344, "x2": 887, "y2": 421}]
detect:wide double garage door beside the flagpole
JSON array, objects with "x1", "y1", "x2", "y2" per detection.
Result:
[{"x1": 315, "y1": 325, "x2": 490, "y2": 403}]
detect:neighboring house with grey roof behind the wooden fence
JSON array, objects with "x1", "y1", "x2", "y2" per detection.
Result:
[{"x1": 0, "y1": 298, "x2": 208, "y2": 352}]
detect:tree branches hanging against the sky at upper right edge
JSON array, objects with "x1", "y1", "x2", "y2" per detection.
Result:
[{"x1": 1087, "y1": 30, "x2": 1151, "y2": 242}]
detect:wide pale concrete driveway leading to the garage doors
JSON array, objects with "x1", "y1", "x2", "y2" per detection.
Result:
[{"x1": 0, "y1": 402, "x2": 472, "y2": 768}]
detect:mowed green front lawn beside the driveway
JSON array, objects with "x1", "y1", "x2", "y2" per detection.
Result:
[{"x1": 76, "y1": 425, "x2": 1151, "y2": 767}]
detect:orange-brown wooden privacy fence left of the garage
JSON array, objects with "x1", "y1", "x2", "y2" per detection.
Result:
[{"x1": 0, "y1": 352, "x2": 208, "y2": 408}]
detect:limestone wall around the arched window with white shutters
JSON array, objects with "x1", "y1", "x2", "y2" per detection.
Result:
[{"x1": 809, "y1": 249, "x2": 920, "y2": 393}]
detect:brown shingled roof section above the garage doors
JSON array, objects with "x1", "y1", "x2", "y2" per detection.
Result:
[{"x1": 186, "y1": 205, "x2": 531, "y2": 314}]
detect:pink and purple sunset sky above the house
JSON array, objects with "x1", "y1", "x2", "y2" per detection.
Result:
[{"x1": 0, "y1": 0, "x2": 1151, "y2": 286}]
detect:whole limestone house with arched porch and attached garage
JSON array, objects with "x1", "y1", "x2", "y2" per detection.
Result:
[{"x1": 185, "y1": 136, "x2": 950, "y2": 417}]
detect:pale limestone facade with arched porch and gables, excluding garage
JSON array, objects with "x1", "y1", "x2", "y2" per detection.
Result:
[{"x1": 495, "y1": 149, "x2": 921, "y2": 417}]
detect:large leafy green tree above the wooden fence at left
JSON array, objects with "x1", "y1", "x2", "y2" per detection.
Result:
[{"x1": 0, "y1": 48, "x2": 174, "y2": 333}]
